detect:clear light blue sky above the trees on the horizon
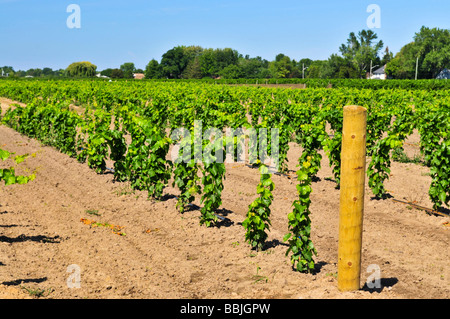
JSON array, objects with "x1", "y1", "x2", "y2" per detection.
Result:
[{"x1": 0, "y1": 0, "x2": 450, "y2": 70}]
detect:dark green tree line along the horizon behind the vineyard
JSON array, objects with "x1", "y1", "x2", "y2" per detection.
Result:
[{"x1": 2, "y1": 26, "x2": 450, "y2": 79}]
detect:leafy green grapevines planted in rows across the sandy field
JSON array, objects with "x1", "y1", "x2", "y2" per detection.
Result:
[{"x1": 0, "y1": 81, "x2": 450, "y2": 271}]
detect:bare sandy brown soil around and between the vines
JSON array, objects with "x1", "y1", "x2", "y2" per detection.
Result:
[{"x1": 0, "y1": 99, "x2": 450, "y2": 299}]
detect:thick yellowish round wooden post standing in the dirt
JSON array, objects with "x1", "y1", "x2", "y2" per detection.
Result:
[{"x1": 338, "y1": 105, "x2": 367, "y2": 291}]
